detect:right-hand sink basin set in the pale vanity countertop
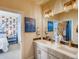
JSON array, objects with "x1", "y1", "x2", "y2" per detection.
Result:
[{"x1": 58, "y1": 46, "x2": 78, "y2": 55}]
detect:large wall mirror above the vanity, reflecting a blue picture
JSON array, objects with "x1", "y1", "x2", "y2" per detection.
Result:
[{"x1": 43, "y1": 18, "x2": 78, "y2": 42}]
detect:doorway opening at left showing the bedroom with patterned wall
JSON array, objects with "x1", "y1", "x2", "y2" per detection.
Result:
[{"x1": 0, "y1": 10, "x2": 22, "y2": 59}]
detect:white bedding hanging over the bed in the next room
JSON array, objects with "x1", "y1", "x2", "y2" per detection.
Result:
[{"x1": 0, "y1": 37, "x2": 9, "y2": 52}]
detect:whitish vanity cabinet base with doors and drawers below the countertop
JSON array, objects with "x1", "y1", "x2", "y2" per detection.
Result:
[{"x1": 34, "y1": 44, "x2": 73, "y2": 59}]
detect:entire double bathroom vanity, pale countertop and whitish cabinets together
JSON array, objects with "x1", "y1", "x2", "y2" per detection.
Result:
[{"x1": 34, "y1": 40, "x2": 78, "y2": 59}]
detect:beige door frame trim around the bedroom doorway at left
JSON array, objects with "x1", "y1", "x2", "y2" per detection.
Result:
[{"x1": 0, "y1": 7, "x2": 24, "y2": 59}]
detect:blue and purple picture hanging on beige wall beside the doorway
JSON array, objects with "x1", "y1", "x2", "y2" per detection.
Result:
[{"x1": 25, "y1": 17, "x2": 36, "y2": 32}]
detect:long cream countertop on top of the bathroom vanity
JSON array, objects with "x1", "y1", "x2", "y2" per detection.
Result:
[{"x1": 34, "y1": 40, "x2": 78, "y2": 59}]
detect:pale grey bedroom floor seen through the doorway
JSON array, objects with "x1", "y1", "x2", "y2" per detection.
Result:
[{"x1": 0, "y1": 44, "x2": 20, "y2": 59}]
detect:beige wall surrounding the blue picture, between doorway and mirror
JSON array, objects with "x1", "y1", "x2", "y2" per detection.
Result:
[{"x1": 0, "y1": 0, "x2": 42, "y2": 59}]
